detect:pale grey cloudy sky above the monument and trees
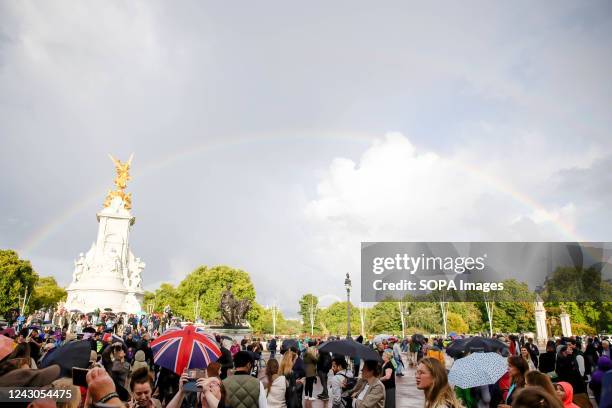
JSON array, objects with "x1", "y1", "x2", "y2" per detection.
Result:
[{"x1": 0, "y1": 0, "x2": 612, "y2": 317}]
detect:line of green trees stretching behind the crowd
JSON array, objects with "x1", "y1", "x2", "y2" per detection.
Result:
[{"x1": 0, "y1": 250, "x2": 612, "y2": 336}]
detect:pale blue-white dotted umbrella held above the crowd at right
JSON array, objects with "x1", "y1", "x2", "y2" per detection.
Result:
[{"x1": 448, "y1": 353, "x2": 508, "y2": 389}]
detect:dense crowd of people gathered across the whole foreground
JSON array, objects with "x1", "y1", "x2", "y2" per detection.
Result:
[{"x1": 0, "y1": 311, "x2": 612, "y2": 408}]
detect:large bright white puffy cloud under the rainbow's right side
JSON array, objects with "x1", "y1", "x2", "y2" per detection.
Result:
[{"x1": 305, "y1": 133, "x2": 592, "y2": 293}]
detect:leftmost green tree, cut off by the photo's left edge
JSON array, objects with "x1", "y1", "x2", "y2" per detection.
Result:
[{"x1": 0, "y1": 249, "x2": 38, "y2": 314}]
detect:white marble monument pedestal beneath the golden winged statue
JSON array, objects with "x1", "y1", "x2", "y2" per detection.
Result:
[{"x1": 65, "y1": 197, "x2": 145, "y2": 313}]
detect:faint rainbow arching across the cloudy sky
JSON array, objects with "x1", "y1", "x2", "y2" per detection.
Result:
[{"x1": 19, "y1": 131, "x2": 583, "y2": 256}]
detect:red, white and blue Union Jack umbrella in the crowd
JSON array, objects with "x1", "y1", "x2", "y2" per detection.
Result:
[{"x1": 151, "y1": 325, "x2": 221, "y2": 375}]
